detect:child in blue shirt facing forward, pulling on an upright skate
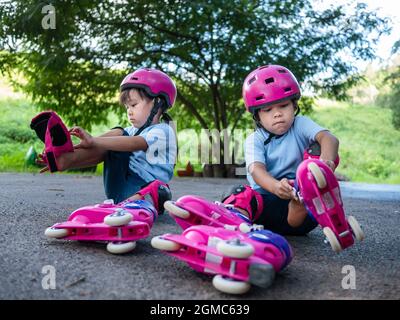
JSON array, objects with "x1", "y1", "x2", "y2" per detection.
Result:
[{"x1": 224, "y1": 65, "x2": 339, "y2": 235}]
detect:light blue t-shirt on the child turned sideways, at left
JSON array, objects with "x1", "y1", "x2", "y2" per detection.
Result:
[{"x1": 125, "y1": 123, "x2": 177, "y2": 183}]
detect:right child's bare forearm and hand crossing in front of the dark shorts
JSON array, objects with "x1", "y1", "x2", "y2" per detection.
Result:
[{"x1": 249, "y1": 162, "x2": 295, "y2": 199}]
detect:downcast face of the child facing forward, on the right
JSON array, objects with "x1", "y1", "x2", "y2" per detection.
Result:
[{"x1": 258, "y1": 101, "x2": 296, "y2": 135}]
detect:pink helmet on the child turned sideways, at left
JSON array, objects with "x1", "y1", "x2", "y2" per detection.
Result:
[{"x1": 120, "y1": 68, "x2": 176, "y2": 108}]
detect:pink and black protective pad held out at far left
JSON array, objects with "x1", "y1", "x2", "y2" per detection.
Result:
[{"x1": 31, "y1": 111, "x2": 74, "y2": 172}]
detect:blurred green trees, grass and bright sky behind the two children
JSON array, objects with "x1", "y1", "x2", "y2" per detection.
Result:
[{"x1": 0, "y1": 0, "x2": 400, "y2": 183}]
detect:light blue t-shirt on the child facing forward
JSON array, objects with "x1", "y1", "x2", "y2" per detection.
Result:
[{"x1": 244, "y1": 116, "x2": 326, "y2": 193}]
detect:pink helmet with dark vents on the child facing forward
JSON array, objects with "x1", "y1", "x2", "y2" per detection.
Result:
[{"x1": 242, "y1": 65, "x2": 301, "y2": 113}]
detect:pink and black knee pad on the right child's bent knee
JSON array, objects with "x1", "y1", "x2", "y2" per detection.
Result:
[{"x1": 222, "y1": 184, "x2": 264, "y2": 221}]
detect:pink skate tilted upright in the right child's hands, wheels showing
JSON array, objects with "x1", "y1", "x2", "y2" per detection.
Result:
[{"x1": 294, "y1": 157, "x2": 364, "y2": 252}]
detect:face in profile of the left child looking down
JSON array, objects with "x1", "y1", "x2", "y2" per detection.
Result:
[{"x1": 125, "y1": 89, "x2": 153, "y2": 128}]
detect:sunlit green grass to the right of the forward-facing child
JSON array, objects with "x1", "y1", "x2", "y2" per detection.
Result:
[{"x1": 311, "y1": 102, "x2": 400, "y2": 183}]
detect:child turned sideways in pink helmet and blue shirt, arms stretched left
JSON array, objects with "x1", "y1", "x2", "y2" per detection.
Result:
[{"x1": 41, "y1": 68, "x2": 177, "y2": 203}]
